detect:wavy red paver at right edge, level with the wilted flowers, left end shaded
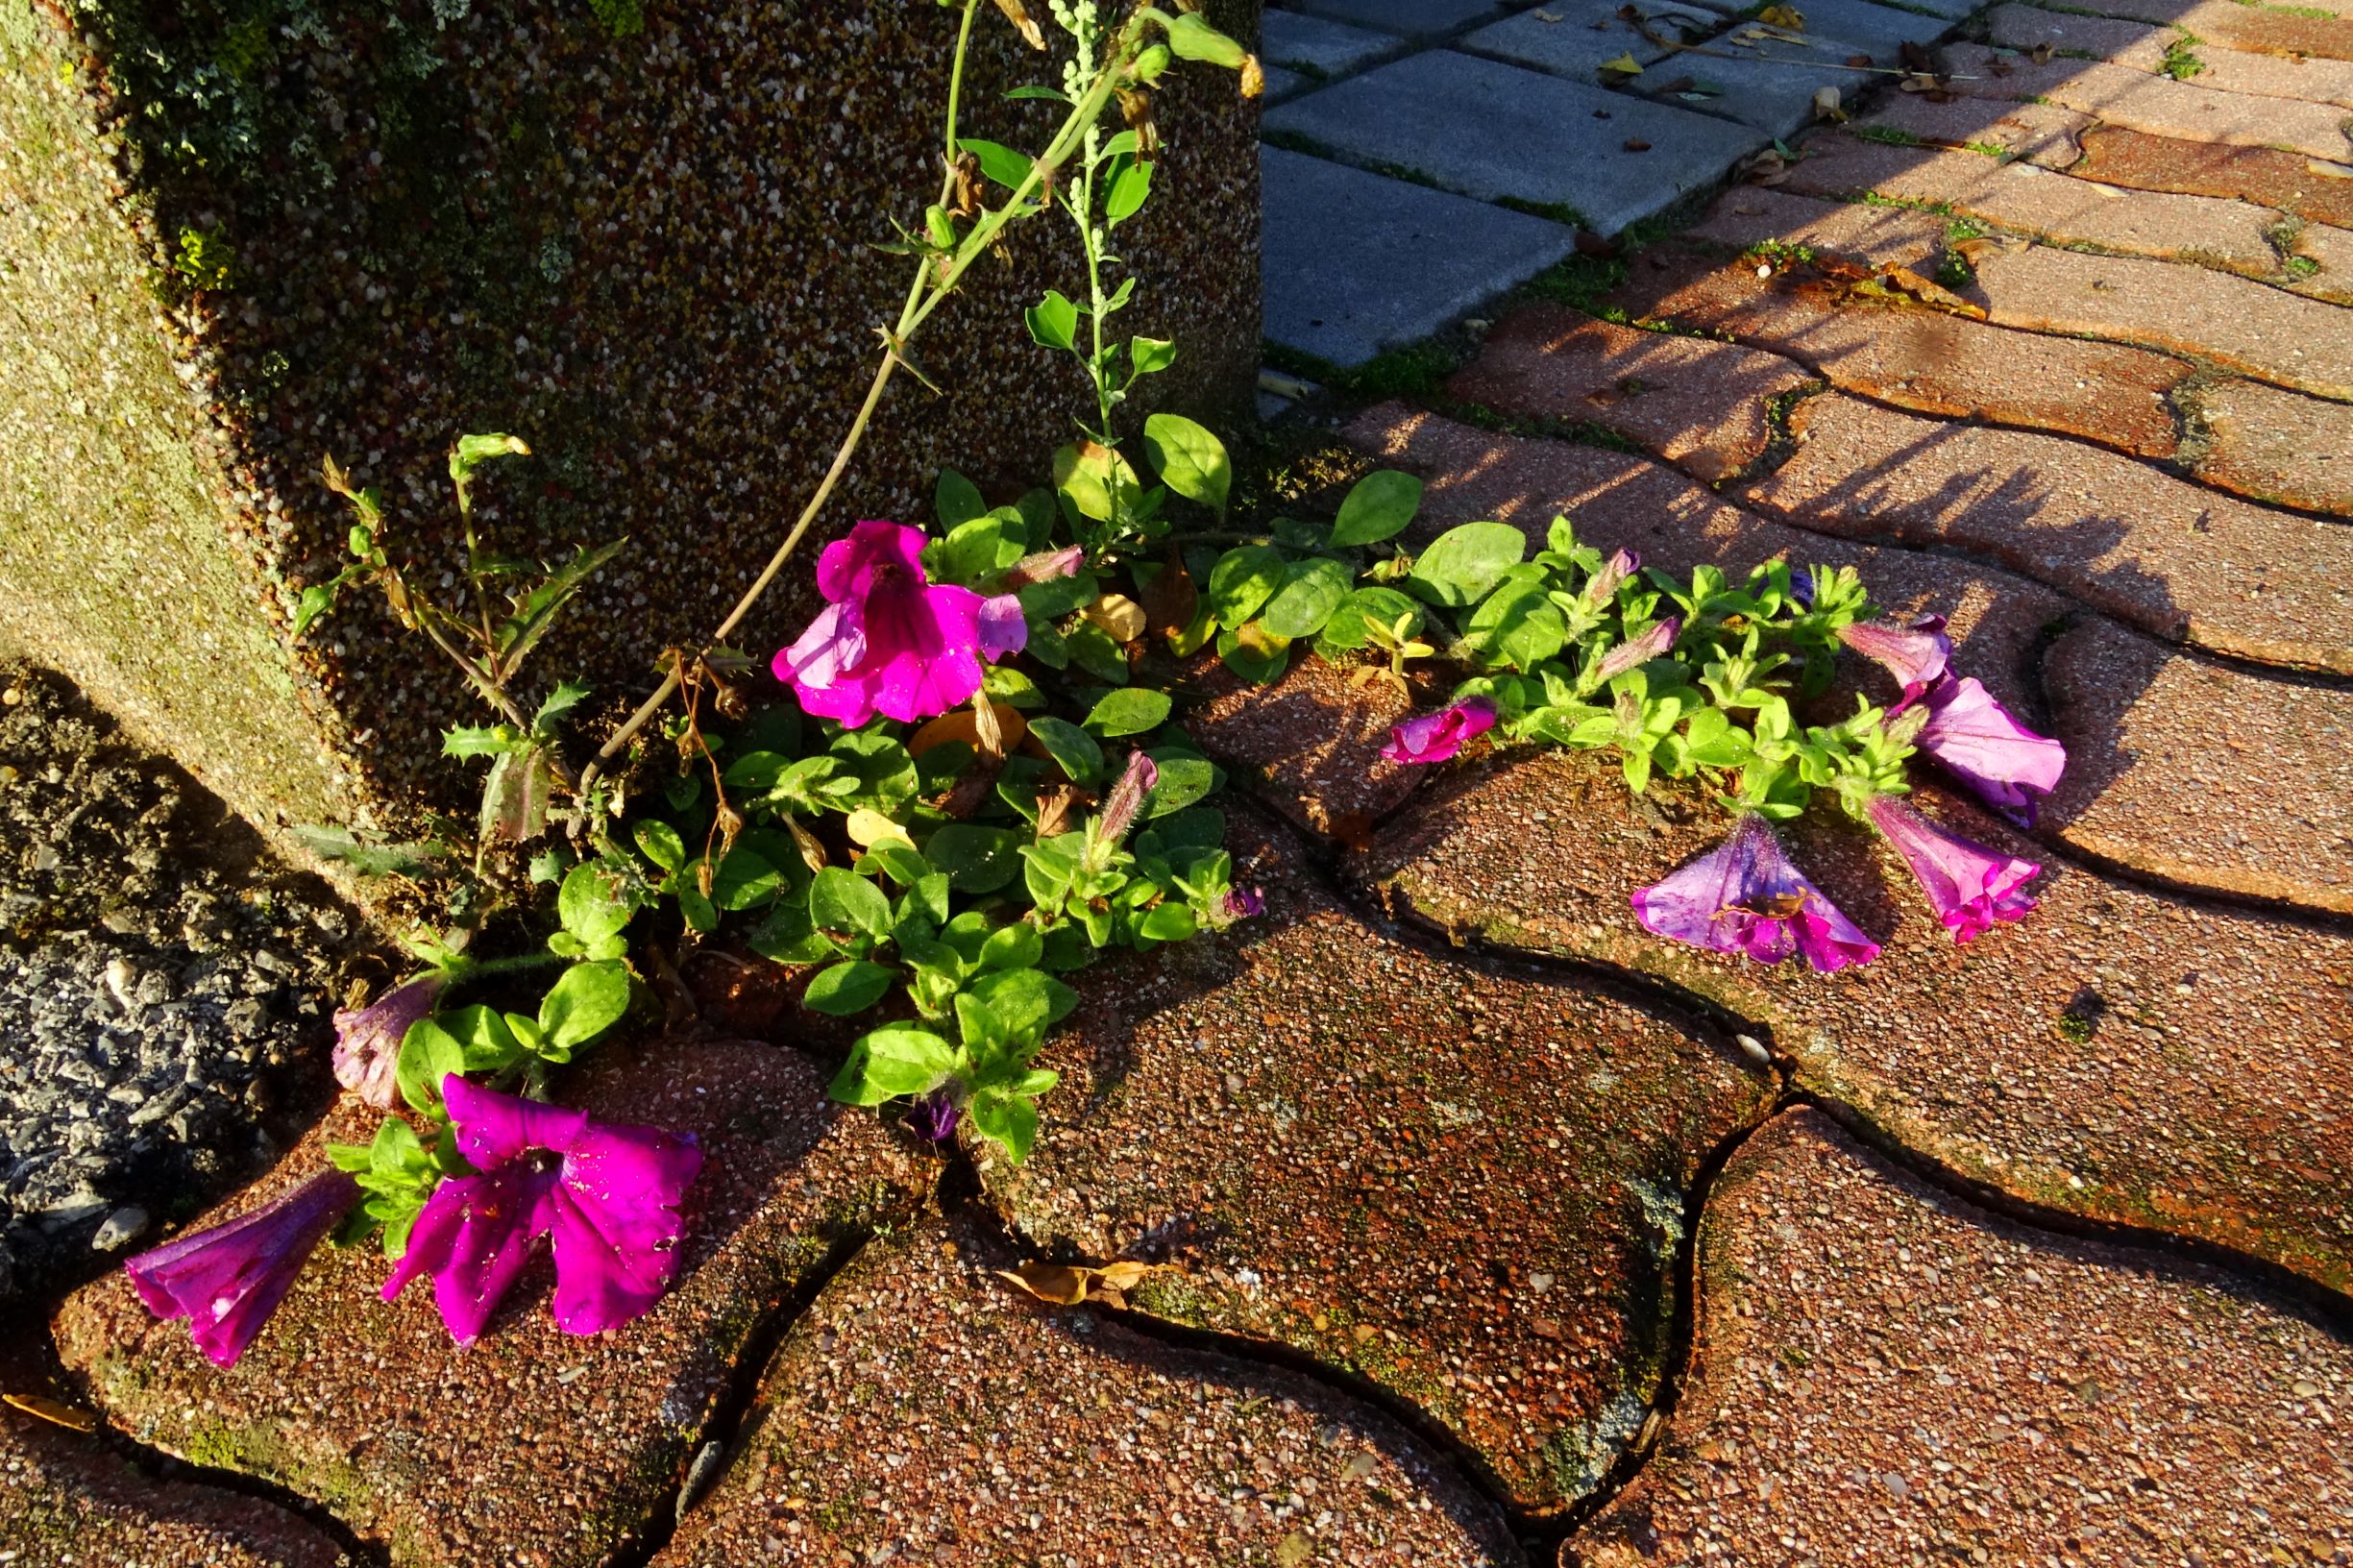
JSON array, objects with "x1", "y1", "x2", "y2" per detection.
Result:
[{"x1": 2043, "y1": 612, "x2": 2353, "y2": 914}]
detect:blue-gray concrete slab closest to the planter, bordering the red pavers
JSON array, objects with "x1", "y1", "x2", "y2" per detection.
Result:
[{"x1": 1262, "y1": 146, "x2": 1577, "y2": 367}]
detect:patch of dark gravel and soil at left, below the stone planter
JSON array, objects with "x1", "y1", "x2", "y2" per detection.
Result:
[{"x1": 0, "y1": 664, "x2": 351, "y2": 1302}]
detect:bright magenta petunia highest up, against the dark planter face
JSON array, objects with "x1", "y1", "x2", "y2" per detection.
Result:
[{"x1": 776, "y1": 521, "x2": 1028, "y2": 727}]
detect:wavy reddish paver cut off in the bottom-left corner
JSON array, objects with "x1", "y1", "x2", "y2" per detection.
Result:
[{"x1": 0, "y1": 1384, "x2": 353, "y2": 1568}]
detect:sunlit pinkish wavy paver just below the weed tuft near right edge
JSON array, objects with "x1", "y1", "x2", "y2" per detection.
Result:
[{"x1": 1974, "y1": 245, "x2": 2353, "y2": 401}]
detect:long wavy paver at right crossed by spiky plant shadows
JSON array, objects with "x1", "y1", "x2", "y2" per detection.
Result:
[{"x1": 1746, "y1": 398, "x2": 2353, "y2": 671}]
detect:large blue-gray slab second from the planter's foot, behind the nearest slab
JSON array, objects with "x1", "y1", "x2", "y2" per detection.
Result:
[{"x1": 1266, "y1": 49, "x2": 1765, "y2": 233}]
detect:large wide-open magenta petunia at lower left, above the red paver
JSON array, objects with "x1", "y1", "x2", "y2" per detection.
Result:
[{"x1": 383, "y1": 1073, "x2": 703, "y2": 1344}]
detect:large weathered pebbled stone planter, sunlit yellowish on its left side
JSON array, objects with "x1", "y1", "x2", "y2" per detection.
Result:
[{"x1": 0, "y1": 0, "x2": 1259, "y2": 843}]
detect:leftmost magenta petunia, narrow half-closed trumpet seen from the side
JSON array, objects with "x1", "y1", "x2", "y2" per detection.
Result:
[{"x1": 122, "y1": 1170, "x2": 360, "y2": 1365}]
